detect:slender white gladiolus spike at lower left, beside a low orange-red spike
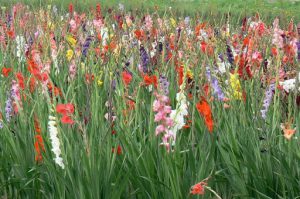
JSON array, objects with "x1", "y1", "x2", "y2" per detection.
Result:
[{"x1": 48, "y1": 115, "x2": 65, "y2": 169}]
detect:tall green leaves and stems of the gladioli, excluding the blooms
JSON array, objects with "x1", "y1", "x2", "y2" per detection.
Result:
[{"x1": 0, "y1": 1, "x2": 300, "y2": 198}]
